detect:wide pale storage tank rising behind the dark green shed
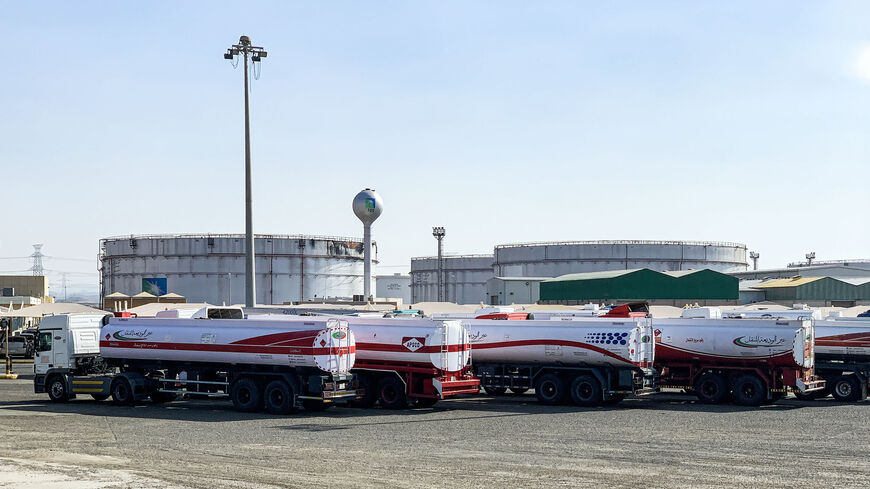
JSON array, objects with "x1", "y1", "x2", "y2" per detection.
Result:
[{"x1": 492, "y1": 240, "x2": 747, "y2": 277}]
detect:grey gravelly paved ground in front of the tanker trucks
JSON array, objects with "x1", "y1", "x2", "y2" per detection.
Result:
[{"x1": 0, "y1": 372, "x2": 870, "y2": 489}]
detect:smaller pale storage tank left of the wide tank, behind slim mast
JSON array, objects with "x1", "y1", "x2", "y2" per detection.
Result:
[{"x1": 411, "y1": 255, "x2": 493, "y2": 304}]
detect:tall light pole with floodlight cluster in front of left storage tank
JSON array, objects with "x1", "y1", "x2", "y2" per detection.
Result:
[{"x1": 224, "y1": 36, "x2": 267, "y2": 307}]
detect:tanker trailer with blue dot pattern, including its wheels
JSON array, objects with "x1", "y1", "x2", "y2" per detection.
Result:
[{"x1": 463, "y1": 318, "x2": 654, "y2": 406}]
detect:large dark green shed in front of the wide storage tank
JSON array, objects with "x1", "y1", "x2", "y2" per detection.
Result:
[{"x1": 540, "y1": 268, "x2": 739, "y2": 305}]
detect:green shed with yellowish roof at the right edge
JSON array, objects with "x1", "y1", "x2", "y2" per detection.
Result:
[{"x1": 753, "y1": 277, "x2": 870, "y2": 307}]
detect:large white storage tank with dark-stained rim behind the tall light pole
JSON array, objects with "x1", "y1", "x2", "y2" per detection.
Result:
[{"x1": 100, "y1": 234, "x2": 377, "y2": 304}]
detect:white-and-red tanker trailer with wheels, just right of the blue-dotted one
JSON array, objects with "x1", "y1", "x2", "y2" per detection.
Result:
[{"x1": 653, "y1": 318, "x2": 824, "y2": 406}]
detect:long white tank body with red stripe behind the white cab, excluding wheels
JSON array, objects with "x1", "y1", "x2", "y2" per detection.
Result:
[{"x1": 100, "y1": 318, "x2": 356, "y2": 372}]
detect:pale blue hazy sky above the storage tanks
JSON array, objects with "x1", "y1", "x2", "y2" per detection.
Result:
[{"x1": 0, "y1": 0, "x2": 870, "y2": 295}]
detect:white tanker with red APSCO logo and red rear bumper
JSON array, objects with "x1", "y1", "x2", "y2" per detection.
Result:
[{"x1": 249, "y1": 315, "x2": 480, "y2": 409}]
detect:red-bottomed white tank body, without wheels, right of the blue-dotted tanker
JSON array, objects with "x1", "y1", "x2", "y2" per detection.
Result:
[{"x1": 653, "y1": 318, "x2": 814, "y2": 368}]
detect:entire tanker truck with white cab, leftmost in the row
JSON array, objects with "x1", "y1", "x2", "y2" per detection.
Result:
[{"x1": 34, "y1": 315, "x2": 358, "y2": 414}]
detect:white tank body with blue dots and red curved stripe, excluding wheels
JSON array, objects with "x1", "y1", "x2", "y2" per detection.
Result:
[{"x1": 463, "y1": 318, "x2": 653, "y2": 366}]
